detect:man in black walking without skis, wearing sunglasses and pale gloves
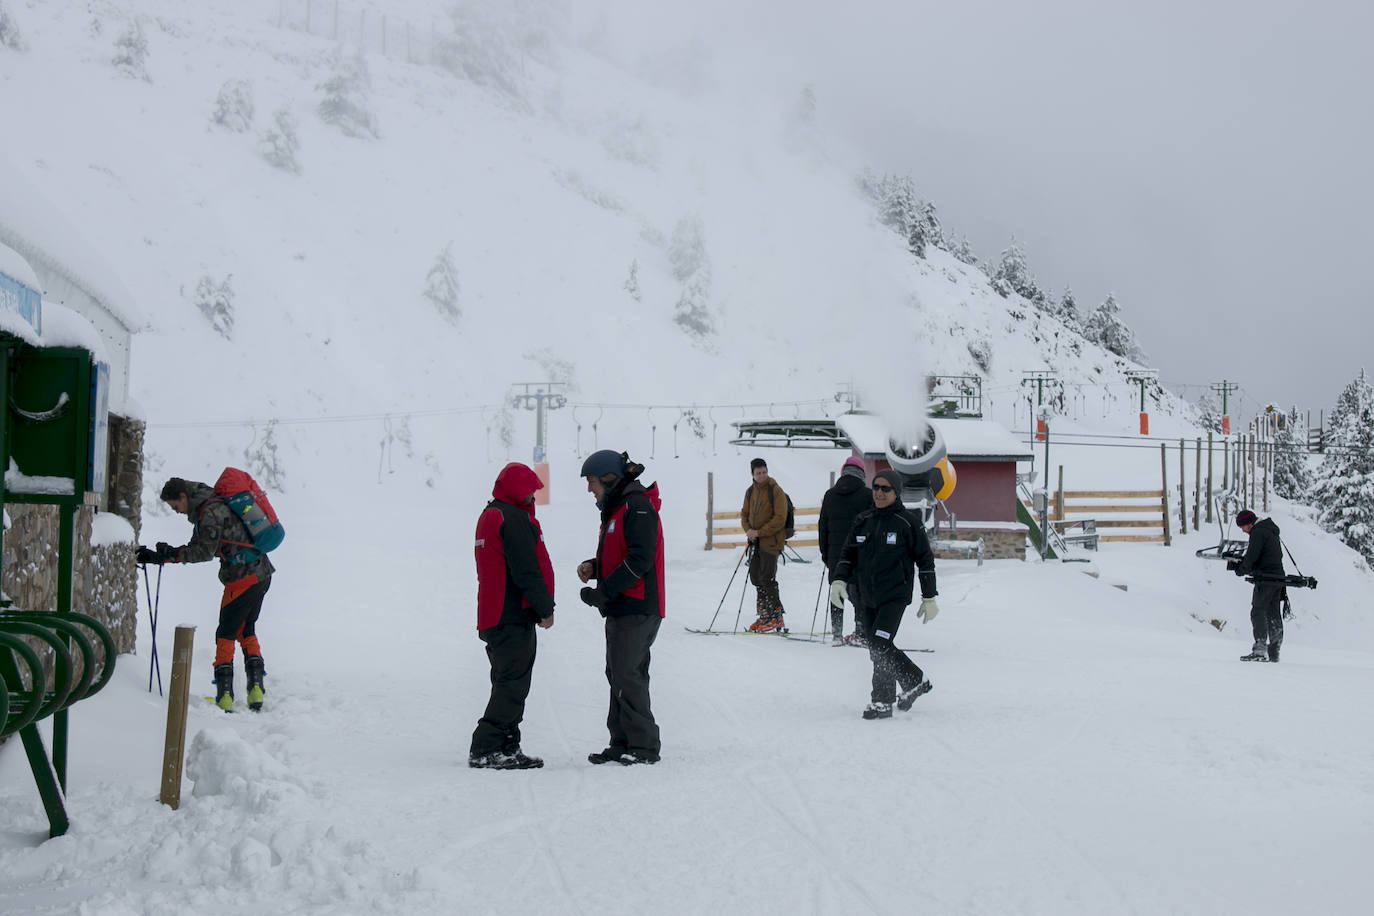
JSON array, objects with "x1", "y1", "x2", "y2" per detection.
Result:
[{"x1": 830, "y1": 468, "x2": 940, "y2": 718}]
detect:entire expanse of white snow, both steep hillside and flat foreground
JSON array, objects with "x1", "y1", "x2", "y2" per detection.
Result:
[{"x1": 0, "y1": 0, "x2": 1374, "y2": 915}]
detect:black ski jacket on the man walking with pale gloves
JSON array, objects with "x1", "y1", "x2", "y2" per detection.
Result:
[{"x1": 833, "y1": 501, "x2": 937, "y2": 607}]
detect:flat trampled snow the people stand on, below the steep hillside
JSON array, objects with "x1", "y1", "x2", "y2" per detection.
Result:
[{"x1": 0, "y1": 444, "x2": 1374, "y2": 915}]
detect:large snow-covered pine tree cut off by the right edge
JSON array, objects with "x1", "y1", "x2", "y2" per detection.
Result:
[{"x1": 1311, "y1": 369, "x2": 1374, "y2": 563}]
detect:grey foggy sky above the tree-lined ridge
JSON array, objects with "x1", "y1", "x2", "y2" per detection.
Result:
[{"x1": 582, "y1": 0, "x2": 1374, "y2": 417}]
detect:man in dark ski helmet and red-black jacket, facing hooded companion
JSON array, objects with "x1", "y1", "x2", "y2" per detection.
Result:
[{"x1": 577, "y1": 449, "x2": 668, "y2": 766}]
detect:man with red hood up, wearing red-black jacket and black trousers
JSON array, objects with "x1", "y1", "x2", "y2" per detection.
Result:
[{"x1": 467, "y1": 461, "x2": 554, "y2": 769}]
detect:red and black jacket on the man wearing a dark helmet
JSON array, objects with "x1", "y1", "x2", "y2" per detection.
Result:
[{"x1": 592, "y1": 481, "x2": 668, "y2": 617}]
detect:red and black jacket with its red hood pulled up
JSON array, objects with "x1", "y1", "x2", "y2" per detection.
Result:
[{"x1": 473, "y1": 461, "x2": 554, "y2": 630}]
